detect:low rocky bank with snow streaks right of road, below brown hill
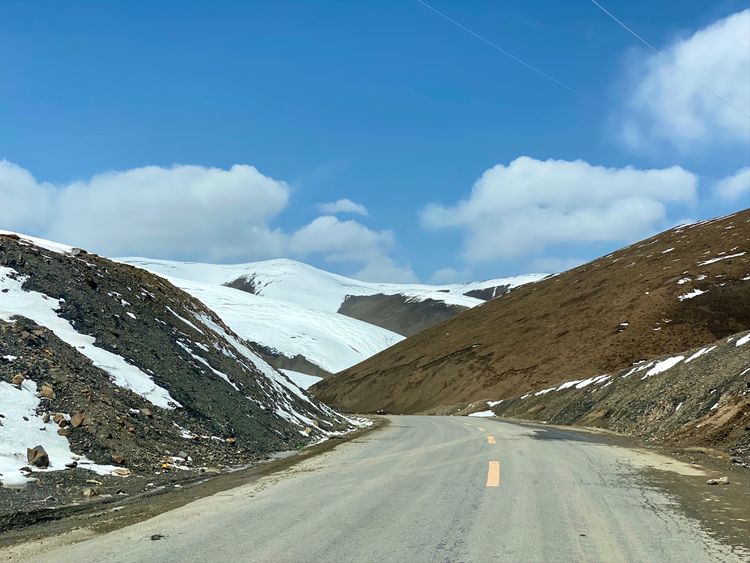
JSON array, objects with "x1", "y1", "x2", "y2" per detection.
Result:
[{"x1": 468, "y1": 332, "x2": 750, "y2": 465}]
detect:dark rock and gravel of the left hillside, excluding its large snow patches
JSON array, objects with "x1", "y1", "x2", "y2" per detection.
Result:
[{"x1": 0, "y1": 231, "x2": 358, "y2": 508}]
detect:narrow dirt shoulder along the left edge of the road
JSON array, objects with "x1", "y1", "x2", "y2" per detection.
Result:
[{"x1": 0, "y1": 417, "x2": 389, "y2": 556}]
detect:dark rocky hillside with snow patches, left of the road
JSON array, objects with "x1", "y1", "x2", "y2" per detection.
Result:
[{"x1": 0, "y1": 233, "x2": 357, "y2": 490}]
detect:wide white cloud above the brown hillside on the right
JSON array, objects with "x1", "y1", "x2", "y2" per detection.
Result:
[{"x1": 422, "y1": 157, "x2": 697, "y2": 263}]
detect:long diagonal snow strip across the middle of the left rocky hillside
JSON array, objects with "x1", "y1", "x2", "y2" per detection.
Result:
[{"x1": 0, "y1": 266, "x2": 182, "y2": 409}]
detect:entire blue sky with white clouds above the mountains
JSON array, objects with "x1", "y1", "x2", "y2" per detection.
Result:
[{"x1": 0, "y1": 0, "x2": 750, "y2": 281}]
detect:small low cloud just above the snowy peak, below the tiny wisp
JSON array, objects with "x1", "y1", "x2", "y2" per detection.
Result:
[{"x1": 289, "y1": 215, "x2": 417, "y2": 282}]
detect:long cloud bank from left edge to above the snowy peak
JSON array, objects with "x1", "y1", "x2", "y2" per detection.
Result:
[{"x1": 0, "y1": 161, "x2": 415, "y2": 281}]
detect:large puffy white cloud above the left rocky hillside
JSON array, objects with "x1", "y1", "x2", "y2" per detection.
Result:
[{"x1": 45, "y1": 165, "x2": 289, "y2": 260}]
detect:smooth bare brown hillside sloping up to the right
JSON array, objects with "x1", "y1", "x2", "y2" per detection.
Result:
[{"x1": 312, "y1": 210, "x2": 750, "y2": 413}]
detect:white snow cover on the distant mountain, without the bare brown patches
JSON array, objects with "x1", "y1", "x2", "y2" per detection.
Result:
[{"x1": 118, "y1": 258, "x2": 545, "y2": 374}]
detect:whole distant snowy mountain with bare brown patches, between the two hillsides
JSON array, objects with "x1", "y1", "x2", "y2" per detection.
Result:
[{"x1": 119, "y1": 258, "x2": 544, "y2": 376}]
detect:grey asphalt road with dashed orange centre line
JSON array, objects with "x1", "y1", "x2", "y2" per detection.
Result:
[{"x1": 10, "y1": 416, "x2": 742, "y2": 563}]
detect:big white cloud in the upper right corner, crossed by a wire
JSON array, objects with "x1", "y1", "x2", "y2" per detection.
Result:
[{"x1": 623, "y1": 10, "x2": 750, "y2": 150}]
